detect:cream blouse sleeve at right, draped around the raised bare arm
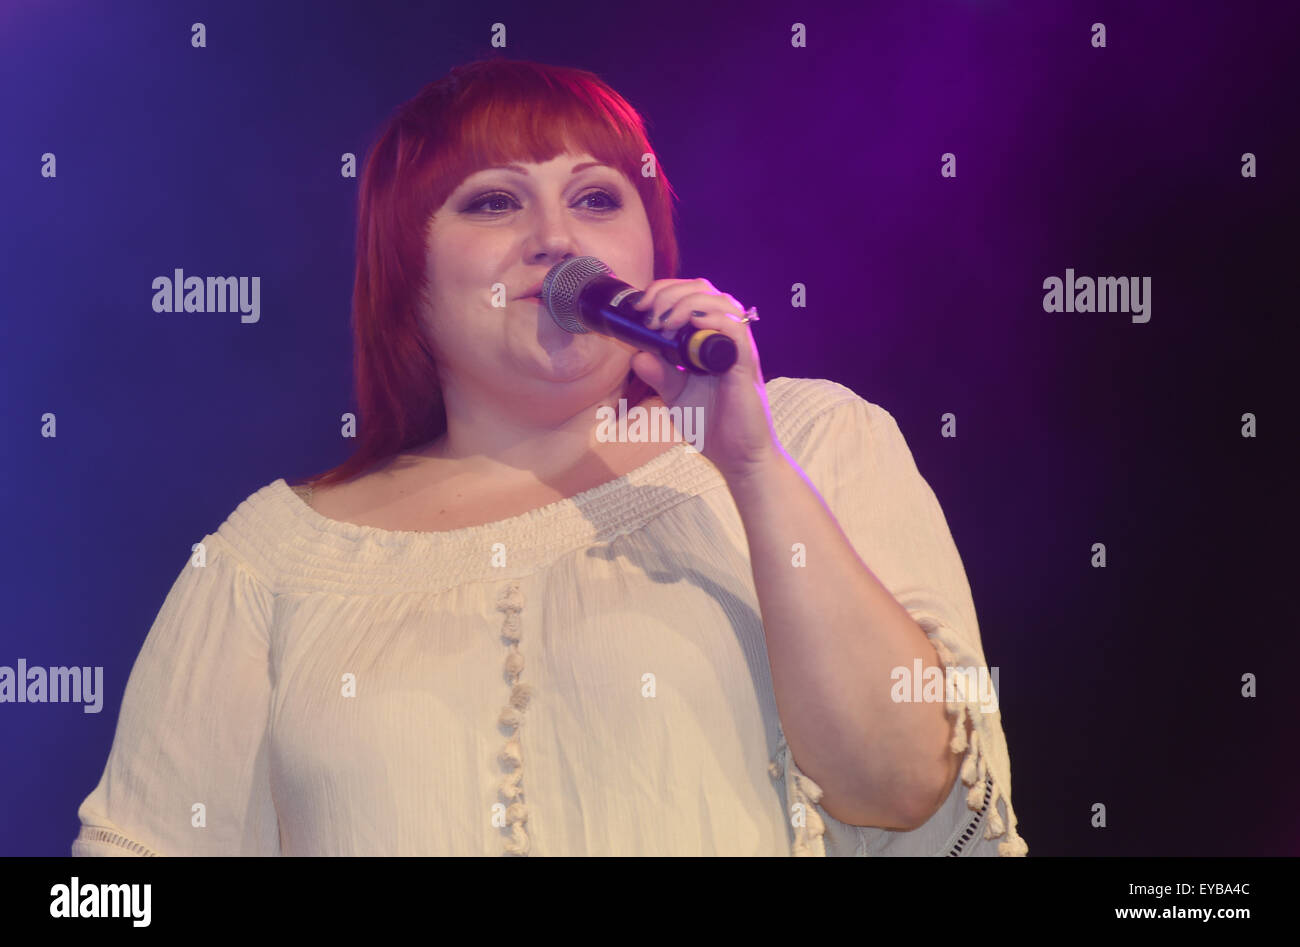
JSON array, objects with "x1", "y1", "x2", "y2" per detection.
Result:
[{"x1": 777, "y1": 380, "x2": 1028, "y2": 856}]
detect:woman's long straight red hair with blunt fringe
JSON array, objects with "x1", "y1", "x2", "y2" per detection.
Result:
[{"x1": 293, "y1": 59, "x2": 679, "y2": 487}]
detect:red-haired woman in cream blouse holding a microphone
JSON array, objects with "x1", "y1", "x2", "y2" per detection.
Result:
[{"x1": 73, "y1": 60, "x2": 1027, "y2": 856}]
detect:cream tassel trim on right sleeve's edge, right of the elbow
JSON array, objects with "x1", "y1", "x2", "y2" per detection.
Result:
[{"x1": 922, "y1": 622, "x2": 1030, "y2": 856}]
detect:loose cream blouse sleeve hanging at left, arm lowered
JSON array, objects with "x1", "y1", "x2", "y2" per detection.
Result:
[{"x1": 72, "y1": 535, "x2": 280, "y2": 856}]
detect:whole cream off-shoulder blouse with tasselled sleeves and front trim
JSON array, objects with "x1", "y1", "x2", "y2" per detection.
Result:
[{"x1": 73, "y1": 379, "x2": 1027, "y2": 856}]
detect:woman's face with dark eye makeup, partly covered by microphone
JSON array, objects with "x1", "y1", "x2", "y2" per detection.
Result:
[{"x1": 423, "y1": 146, "x2": 654, "y2": 415}]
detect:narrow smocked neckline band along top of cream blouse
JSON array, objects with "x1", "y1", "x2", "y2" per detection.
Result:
[{"x1": 270, "y1": 441, "x2": 686, "y2": 545}]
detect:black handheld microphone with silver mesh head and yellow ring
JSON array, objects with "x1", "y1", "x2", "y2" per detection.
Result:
[{"x1": 542, "y1": 256, "x2": 736, "y2": 375}]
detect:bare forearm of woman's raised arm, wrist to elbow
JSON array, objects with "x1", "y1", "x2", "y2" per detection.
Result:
[{"x1": 727, "y1": 451, "x2": 961, "y2": 830}]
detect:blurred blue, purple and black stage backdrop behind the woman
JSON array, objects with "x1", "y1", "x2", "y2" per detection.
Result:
[{"x1": 0, "y1": 0, "x2": 1300, "y2": 856}]
